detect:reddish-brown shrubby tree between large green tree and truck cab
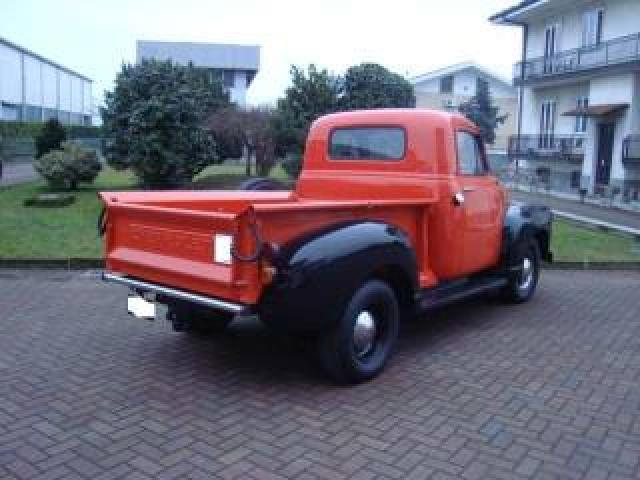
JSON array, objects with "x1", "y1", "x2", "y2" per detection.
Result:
[{"x1": 209, "y1": 106, "x2": 276, "y2": 176}]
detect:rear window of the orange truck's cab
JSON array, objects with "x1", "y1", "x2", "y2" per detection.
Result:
[{"x1": 329, "y1": 127, "x2": 406, "y2": 160}]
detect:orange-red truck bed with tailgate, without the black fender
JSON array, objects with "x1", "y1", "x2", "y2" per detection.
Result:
[{"x1": 100, "y1": 191, "x2": 438, "y2": 305}]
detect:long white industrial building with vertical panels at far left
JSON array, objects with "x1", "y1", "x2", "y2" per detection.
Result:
[{"x1": 0, "y1": 37, "x2": 92, "y2": 125}]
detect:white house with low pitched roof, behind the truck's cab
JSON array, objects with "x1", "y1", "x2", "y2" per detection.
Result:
[{"x1": 410, "y1": 62, "x2": 518, "y2": 152}]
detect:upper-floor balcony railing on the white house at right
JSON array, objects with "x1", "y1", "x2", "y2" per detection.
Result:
[{"x1": 513, "y1": 33, "x2": 640, "y2": 84}]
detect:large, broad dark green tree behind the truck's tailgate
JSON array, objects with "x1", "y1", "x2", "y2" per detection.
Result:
[{"x1": 102, "y1": 60, "x2": 229, "y2": 186}]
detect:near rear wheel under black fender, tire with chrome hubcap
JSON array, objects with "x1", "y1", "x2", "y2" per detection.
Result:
[{"x1": 318, "y1": 280, "x2": 400, "y2": 384}]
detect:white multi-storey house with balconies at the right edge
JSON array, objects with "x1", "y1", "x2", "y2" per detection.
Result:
[{"x1": 490, "y1": 0, "x2": 640, "y2": 201}]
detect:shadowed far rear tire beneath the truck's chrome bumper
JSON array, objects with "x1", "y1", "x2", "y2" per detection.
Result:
[{"x1": 167, "y1": 303, "x2": 233, "y2": 335}]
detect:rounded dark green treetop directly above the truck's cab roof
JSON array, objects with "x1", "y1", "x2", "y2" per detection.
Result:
[{"x1": 340, "y1": 63, "x2": 416, "y2": 110}]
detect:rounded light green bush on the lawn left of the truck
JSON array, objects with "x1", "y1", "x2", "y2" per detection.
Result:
[{"x1": 33, "y1": 142, "x2": 102, "y2": 190}]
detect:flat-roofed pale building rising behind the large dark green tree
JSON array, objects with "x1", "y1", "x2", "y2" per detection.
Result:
[{"x1": 136, "y1": 40, "x2": 260, "y2": 106}]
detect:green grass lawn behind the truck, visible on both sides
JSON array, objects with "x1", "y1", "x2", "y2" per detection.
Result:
[{"x1": 0, "y1": 165, "x2": 640, "y2": 262}]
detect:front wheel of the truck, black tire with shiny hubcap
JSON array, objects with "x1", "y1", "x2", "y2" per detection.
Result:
[{"x1": 503, "y1": 239, "x2": 540, "y2": 303}]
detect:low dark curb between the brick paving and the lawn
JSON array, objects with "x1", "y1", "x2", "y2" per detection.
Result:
[{"x1": 0, "y1": 258, "x2": 640, "y2": 271}]
